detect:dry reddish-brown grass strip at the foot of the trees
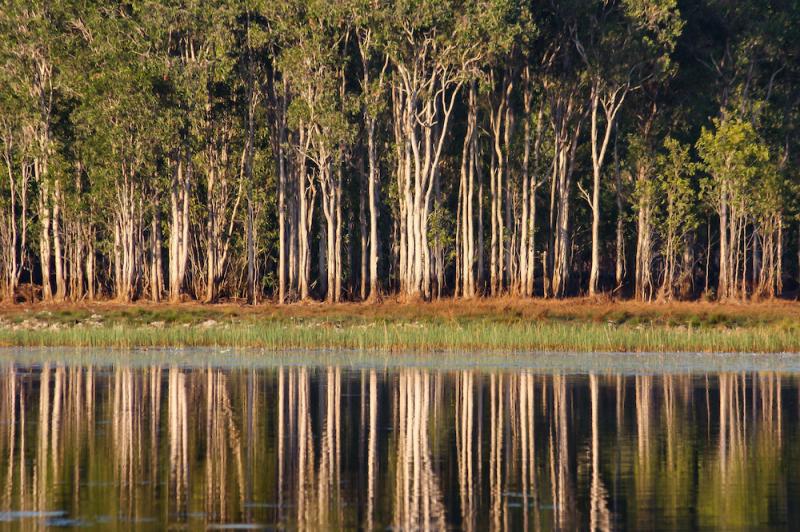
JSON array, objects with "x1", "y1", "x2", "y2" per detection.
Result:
[{"x1": 0, "y1": 297, "x2": 800, "y2": 323}]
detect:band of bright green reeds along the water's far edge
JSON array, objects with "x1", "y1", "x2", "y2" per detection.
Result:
[{"x1": 0, "y1": 318, "x2": 800, "y2": 352}]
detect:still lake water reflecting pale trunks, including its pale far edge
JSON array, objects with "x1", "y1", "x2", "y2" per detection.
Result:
[{"x1": 0, "y1": 350, "x2": 800, "y2": 530}]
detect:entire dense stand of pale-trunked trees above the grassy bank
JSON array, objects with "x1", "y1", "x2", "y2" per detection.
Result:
[{"x1": 0, "y1": 0, "x2": 800, "y2": 303}]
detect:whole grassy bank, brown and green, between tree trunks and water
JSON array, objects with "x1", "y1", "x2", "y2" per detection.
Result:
[{"x1": 0, "y1": 297, "x2": 800, "y2": 352}]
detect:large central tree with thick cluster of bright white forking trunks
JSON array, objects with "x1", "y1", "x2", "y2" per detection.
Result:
[{"x1": 385, "y1": 0, "x2": 484, "y2": 298}]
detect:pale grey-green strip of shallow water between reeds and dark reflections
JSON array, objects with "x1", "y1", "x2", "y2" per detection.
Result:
[{"x1": 0, "y1": 347, "x2": 800, "y2": 375}]
